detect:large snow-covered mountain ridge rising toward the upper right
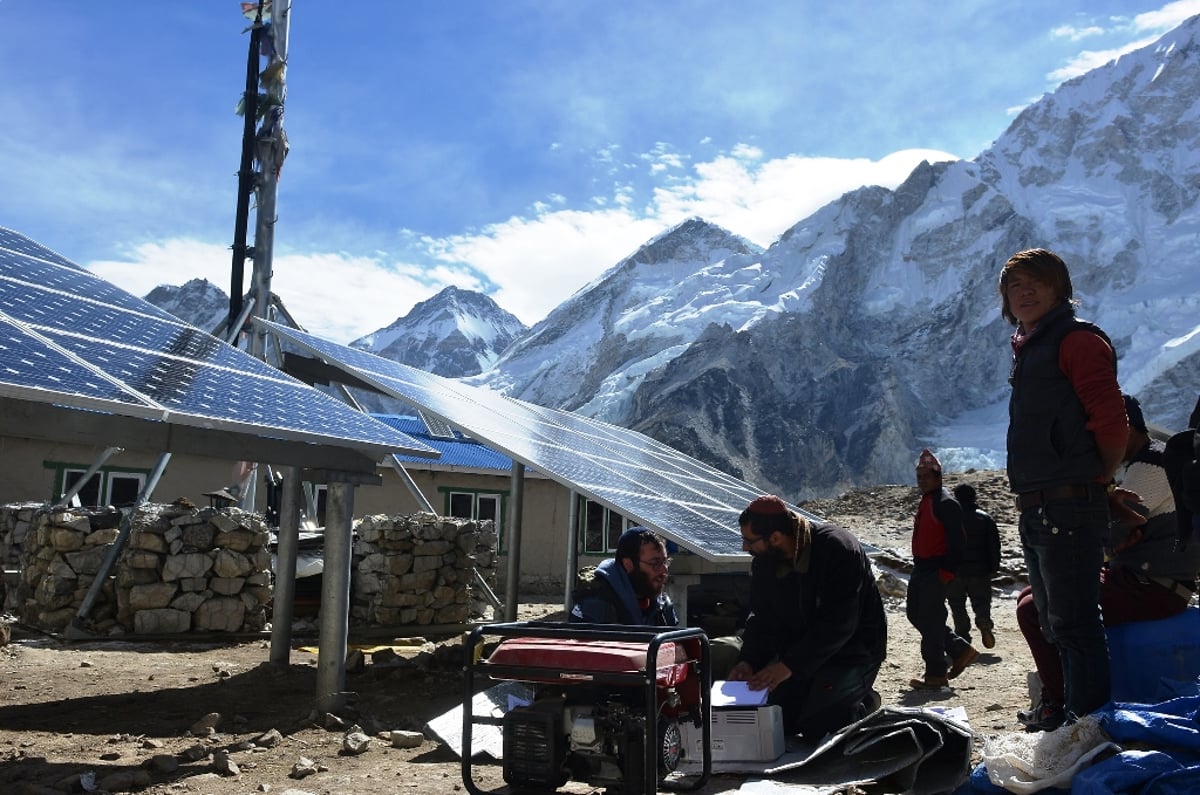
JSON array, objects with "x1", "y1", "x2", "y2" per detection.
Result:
[{"x1": 472, "y1": 12, "x2": 1200, "y2": 498}]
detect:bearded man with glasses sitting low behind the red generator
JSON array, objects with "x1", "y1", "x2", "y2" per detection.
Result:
[{"x1": 569, "y1": 527, "x2": 679, "y2": 627}]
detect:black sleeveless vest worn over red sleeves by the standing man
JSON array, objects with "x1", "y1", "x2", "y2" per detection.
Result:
[{"x1": 1008, "y1": 303, "x2": 1116, "y2": 494}]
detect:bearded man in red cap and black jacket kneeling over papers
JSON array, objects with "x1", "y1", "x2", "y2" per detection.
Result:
[{"x1": 726, "y1": 495, "x2": 888, "y2": 742}]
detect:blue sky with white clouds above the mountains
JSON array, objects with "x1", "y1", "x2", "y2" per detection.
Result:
[{"x1": 0, "y1": 0, "x2": 1200, "y2": 342}]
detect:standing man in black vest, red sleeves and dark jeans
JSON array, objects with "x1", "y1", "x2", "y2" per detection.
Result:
[{"x1": 1000, "y1": 249, "x2": 1129, "y2": 722}]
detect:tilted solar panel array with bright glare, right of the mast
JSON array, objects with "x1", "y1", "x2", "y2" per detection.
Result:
[{"x1": 254, "y1": 319, "x2": 787, "y2": 560}]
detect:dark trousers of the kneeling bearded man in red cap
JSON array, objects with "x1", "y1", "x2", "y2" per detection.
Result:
[{"x1": 768, "y1": 663, "x2": 880, "y2": 742}]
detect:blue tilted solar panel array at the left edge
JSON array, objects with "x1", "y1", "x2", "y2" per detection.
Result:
[{"x1": 0, "y1": 228, "x2": 436, "y2": 458}]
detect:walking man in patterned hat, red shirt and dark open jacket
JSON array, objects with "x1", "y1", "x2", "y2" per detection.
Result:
[{"x1": 905, "y1": 448, "x2": 979, "y2": 689}]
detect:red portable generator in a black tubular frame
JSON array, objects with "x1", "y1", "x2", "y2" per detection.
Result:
[{"x1": 462, "y1": 621, "x2": 712, "y2": 795}]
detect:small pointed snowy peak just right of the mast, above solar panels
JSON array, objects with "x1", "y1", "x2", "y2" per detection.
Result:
[{"x1": 350, "y1": 287, "x2": 526, "y2": 378}]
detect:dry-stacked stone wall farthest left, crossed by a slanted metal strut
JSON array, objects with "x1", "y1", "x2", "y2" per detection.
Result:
[{"x1": 14, "y1": 503, "x2": 271, "y2": 635}]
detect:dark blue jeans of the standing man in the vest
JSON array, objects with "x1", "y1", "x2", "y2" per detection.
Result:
[{"x1": 1020, "y1": 492, "x2": 1111, "y2": 716}]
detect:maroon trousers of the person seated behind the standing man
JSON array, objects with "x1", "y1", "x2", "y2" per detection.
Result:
[{"x1": 1016, "y1": 567, "x2": 1188, "y2": 705}]
